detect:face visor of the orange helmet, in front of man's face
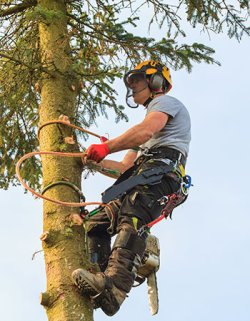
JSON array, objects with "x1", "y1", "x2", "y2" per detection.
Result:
[{"x1": 124, "y1": 70, "x2": 148, "y2": 108}]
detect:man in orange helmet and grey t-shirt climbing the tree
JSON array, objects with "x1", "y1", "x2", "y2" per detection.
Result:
[{"x1": 72, "y1": 60, "x2": 191, "y2": 316}]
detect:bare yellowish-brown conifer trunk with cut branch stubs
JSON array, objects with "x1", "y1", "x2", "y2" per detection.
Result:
[{"x1": 38, "y1": 0, "x2": 93, "y2": 321}]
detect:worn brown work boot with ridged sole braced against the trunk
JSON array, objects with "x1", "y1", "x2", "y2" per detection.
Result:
[{"x1": 72, "y1": 269, "x2": 127, "y2": 316}]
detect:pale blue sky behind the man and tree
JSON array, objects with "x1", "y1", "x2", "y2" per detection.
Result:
[{"x1": 0, "y1": 8, "x2": 250, "y2": 321}]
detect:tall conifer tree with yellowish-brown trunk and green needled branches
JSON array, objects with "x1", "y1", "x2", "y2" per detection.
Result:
[{"x1": 0, "y1": 0, "x2": 249, "y2": 321}]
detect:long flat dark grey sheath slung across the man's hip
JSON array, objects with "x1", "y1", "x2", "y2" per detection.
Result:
[{"x1": 102, "y1": 164, "x2": 174, "y2": 203}]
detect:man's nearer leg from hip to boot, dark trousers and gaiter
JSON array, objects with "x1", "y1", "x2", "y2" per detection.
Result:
[{"x1": 72, "y1": 170, "x2": 179, "y2": 316}]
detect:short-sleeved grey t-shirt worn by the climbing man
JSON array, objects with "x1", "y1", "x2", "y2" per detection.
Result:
[{"x1": 140, "y1": 95, "x2": 191, "y2": 157}]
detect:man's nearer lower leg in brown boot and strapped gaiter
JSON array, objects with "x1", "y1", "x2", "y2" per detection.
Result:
[{"x1": 72, "y1": 228, "x2": 146, "y2": 316}]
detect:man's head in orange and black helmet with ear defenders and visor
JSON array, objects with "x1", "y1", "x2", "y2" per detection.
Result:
[{"x1": 124, "y1": 60, "x2": 172, "y2": 108}]
